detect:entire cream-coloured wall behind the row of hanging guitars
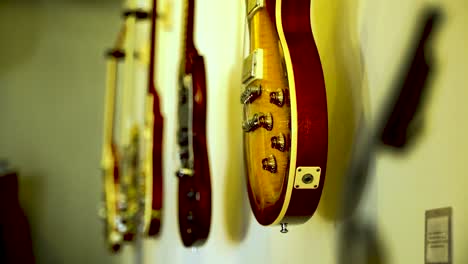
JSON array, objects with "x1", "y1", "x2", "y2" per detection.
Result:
[{"x1": 0, "y1": 0, "x2": 468, "y2": 264}]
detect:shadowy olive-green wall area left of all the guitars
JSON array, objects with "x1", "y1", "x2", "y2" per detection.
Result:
[{"x1": 0, "y1": 1, "x2": 128, "y2": 264}]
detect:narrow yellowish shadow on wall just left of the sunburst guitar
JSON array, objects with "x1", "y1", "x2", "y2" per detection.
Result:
[{"x1": 224, "y1": 0, "x2": 251, "y2": 243}]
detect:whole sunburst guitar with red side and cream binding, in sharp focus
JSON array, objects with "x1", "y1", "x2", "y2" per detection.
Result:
[{"x1": 241, "y1": 0, "x2": 328, "y2": 230}]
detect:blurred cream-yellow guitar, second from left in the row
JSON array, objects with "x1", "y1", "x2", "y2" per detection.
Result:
[{"x1": 119, "y1": 0, "x2": 141, "y2": 241}]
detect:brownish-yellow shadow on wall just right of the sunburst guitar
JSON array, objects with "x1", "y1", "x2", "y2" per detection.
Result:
[{"x1": 311, "y1": 0, "x2": 366, "y2": 221}]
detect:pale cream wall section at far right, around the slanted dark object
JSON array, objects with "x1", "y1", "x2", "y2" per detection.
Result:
[{"x1": 362, "y1": 0, "x2": 468, "y2": 264}]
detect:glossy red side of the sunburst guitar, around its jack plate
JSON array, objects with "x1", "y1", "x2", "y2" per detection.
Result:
[{"x1": 281, "y1": 0, "x2": 328, "y2": 223}]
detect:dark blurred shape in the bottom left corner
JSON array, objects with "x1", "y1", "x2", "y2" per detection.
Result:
[{"x1": 0, "y1": 162, "x2": 35, "y2": 264}]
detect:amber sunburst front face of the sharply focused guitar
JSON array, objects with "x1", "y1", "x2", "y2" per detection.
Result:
[{"x1": 242, "y1": 1, "x2": 291, "y2": 225}]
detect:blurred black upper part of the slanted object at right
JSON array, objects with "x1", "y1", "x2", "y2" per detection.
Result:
[{"x1": 381, "y1": 9, "x2": 441, "y2": 148}]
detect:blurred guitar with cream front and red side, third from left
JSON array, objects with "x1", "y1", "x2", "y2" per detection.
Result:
[{"x1": 142, "y1": 0, "x2": 163, "y2": 236}]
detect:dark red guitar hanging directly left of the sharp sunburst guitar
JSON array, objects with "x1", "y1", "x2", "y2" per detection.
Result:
[{"x1": 176, "y1": 0, "x2": 211, "y2": 247}]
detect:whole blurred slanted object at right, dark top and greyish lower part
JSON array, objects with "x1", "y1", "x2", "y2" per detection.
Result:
[{"x1": 338, "y1": 8, "x2": 441, "y2": 264}]
